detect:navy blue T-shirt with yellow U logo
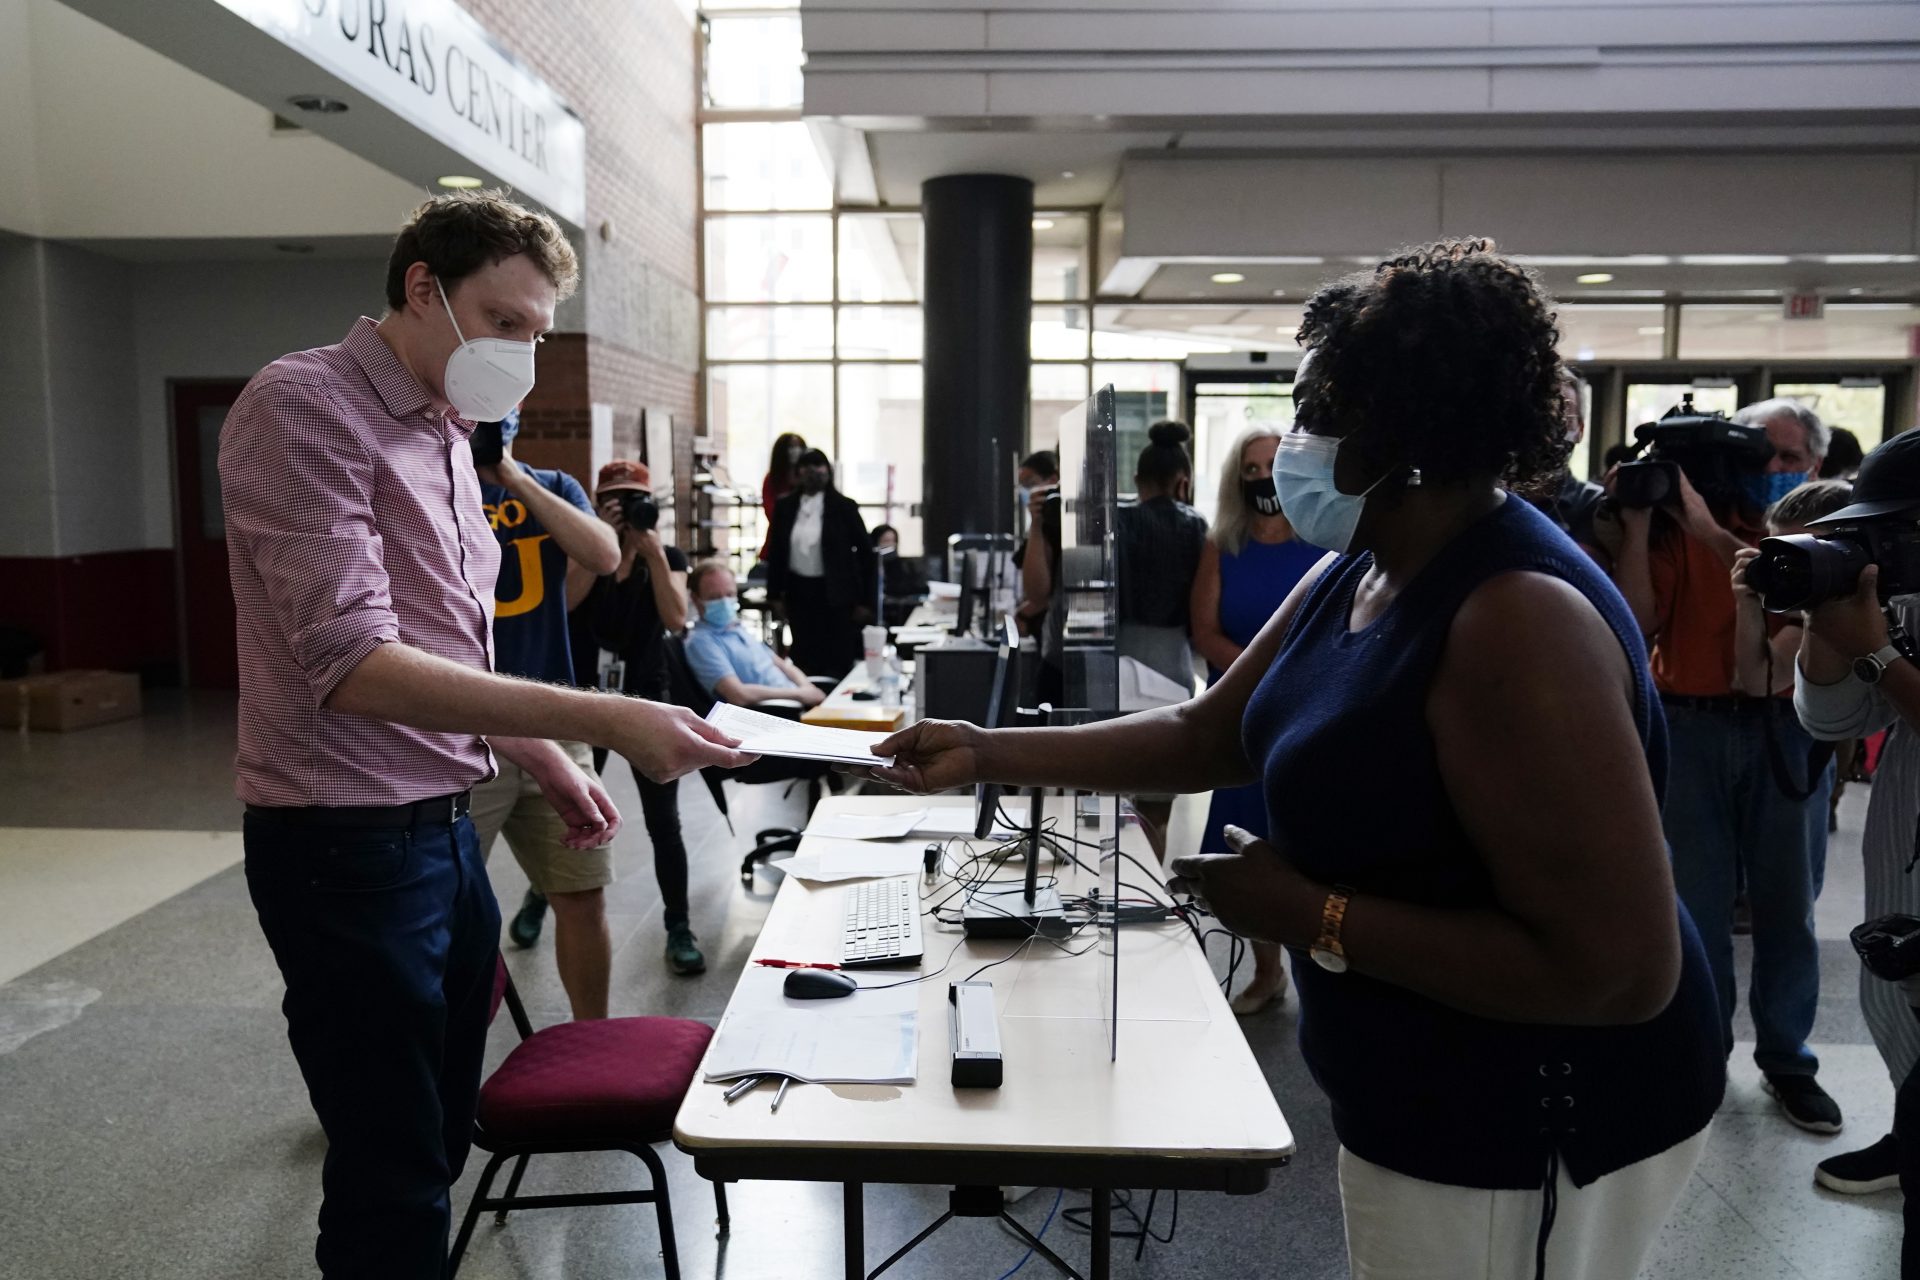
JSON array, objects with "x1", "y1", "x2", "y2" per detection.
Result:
[{"x1": 480, "y1": 466, "x2": 593, "y2": 685}]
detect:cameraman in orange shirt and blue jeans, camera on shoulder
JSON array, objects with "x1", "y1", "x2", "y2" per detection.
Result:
[{"x1": 1607, "y1": 397, "x2": 1841, "y2": 1132}]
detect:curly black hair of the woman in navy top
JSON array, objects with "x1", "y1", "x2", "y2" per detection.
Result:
[{"x1": 1294, "y1": 240, "x2": 1572, "y2": 489}]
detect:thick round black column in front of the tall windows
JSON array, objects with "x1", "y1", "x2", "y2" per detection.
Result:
[{"x1": 920, "y1": 173, "x2": 1033, "y2": 557}]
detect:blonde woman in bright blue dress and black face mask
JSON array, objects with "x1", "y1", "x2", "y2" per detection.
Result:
[{"x1": 1190, "y1": 424, "x2": 1327, "y2": 1013}]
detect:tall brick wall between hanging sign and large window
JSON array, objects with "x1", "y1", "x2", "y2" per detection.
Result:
[{"x1": 463, "y1": 0, "x2": 701, "y2": 529}]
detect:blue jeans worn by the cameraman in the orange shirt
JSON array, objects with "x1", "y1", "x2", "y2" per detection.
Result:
[{"x1": 1663, "y1": 699, "x2": 1834, "y2": 1075}]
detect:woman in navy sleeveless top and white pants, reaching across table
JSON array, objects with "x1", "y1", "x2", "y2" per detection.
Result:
[{"x1": 876, "y1": 240, "x2": 1726, "y2": 1280}]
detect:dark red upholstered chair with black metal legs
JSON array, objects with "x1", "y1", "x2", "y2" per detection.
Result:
[{"x1": 447, "y1": 960, "x2": 730, "y2": 1280}]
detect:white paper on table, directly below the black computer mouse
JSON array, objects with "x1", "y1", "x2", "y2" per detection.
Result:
[{"x1": 707, "y1": 1013, "x2": 920, "y2": 1084}]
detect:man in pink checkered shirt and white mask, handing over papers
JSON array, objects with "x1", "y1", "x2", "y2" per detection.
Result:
[{"x1": 219, "y1": 192, "x2": 749, "y2": 1280}]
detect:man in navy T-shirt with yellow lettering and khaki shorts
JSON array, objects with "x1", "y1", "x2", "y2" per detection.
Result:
[{"x1": 472, "y1": 411, "x2": 620, "y2": 1019}]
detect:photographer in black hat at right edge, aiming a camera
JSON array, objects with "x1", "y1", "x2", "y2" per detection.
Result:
[{"x1": 1747, "y1": 434, "x2": 1920, "y2": 1251}]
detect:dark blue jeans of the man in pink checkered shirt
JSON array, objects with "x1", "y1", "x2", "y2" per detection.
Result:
[{"x1": 246, "y1": 814, "x2": 499, "y2": 1280}]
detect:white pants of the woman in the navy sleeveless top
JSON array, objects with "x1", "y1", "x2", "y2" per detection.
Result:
[{"x1": 1340, "y1": 1130, "x2": 1707, "y2": 1280}]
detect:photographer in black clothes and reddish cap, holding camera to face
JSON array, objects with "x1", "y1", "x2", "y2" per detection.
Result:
[{"x1": 566, "y1": 459, "x2": 707, "y2": 975}]
